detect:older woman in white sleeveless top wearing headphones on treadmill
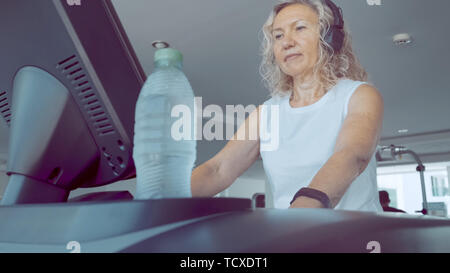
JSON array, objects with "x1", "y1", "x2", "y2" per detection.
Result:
[{"x1": 191, "y1": 0, "x2": 383, "y2": 211}]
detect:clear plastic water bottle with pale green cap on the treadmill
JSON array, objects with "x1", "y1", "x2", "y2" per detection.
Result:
[{"x1": 133, "y1": 41, "x2": 196, "y2": 199}]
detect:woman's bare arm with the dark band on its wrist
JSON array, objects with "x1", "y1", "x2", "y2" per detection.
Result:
[{"x1": 291, "y1": 85, "x2": 384, "y2": 208}]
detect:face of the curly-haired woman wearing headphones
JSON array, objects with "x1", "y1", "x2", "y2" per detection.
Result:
[{"x1": 272, "y1": 4, "x2": 320, "y2": 78}]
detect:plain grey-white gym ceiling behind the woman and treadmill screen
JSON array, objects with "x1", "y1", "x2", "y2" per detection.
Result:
[{"x1": 0, "y1": 0, "x2": 450, "y2": 167}]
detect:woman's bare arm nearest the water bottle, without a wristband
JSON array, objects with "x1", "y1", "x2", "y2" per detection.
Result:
[{"x1": 191, "y1": 107, "x2": 259, "y2": 197}]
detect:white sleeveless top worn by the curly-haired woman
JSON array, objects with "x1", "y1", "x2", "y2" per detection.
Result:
[{"x1": 260, "y1": 79, "x2": 382, "y2": 212}]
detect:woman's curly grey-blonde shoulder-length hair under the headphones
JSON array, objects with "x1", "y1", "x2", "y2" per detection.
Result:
[{"x1": 260, "y1": 0, "x2": 367, "y2": 96}]
